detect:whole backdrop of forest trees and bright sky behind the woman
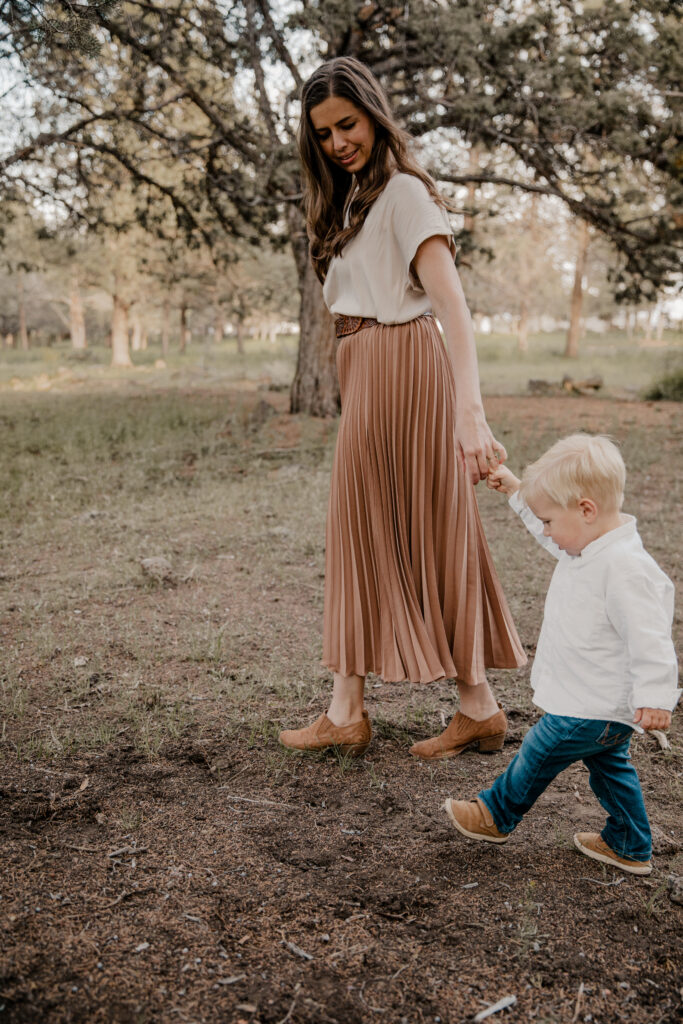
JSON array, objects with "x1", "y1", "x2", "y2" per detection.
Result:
[{"x1": 0, "y1": 0, "x2": 683, "y2": 414}]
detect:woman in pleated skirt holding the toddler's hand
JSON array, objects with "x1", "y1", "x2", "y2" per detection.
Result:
[{"x1": 280, "y1": 57, "x2": 525, "y2": 759}]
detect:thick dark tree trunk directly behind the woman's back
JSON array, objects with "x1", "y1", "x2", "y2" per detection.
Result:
[{"x1": 289, "y1": 207, "x2": 341, "y2": 416}]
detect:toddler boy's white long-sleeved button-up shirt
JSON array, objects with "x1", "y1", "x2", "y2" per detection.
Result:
[{"x1": 509, "y1": 493, "x2": 681, "y2": 731}]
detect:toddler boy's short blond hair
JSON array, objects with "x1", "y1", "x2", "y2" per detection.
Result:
[{"x1": 519, "y1": 434, "x2": 626, "y2": 512}]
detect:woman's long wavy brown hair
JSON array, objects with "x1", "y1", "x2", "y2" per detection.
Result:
[{"x1": 297, "y1": 57, "x2": 444, "y2": 281}]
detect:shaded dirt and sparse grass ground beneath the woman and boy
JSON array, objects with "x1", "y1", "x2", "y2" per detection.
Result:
[{"x1": 0, "y1": 393, "x2": 683, "y2": 1024}]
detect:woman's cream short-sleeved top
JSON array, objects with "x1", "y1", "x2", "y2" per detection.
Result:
[{"x1": 323, "y1": 173, "x2": 456, "y2": 324}]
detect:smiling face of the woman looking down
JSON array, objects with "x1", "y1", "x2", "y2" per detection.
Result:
[{"x1": 310, "y1": 96, "x2": 375, "y2": 174}]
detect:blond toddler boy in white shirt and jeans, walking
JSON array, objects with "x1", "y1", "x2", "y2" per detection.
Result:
[{"x1": 443, "y1": 434, "x2": 680, "y2": 874}]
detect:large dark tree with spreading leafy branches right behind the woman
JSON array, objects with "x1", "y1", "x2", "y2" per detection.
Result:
[{"x1": 0, "y1": 0, "x2": 683, "y2": 413}]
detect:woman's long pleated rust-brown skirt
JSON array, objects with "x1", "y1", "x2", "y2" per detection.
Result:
[{"x1": 323, "y1": 316, "x2": 526, "y2": 684}]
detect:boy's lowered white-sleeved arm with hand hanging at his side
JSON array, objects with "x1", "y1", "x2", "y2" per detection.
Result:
[{"x1": 606, "y1": 571, "x2": 681, "y2": 729}]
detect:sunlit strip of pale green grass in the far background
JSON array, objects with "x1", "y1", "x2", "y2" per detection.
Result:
[{"x1": 0, "y1": 331, "x2": 683, "y2": 396}]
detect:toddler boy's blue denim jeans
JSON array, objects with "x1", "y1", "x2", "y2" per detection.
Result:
[{"x1": 479, "y1": 715, "x2": 652, "y2": 860}]
